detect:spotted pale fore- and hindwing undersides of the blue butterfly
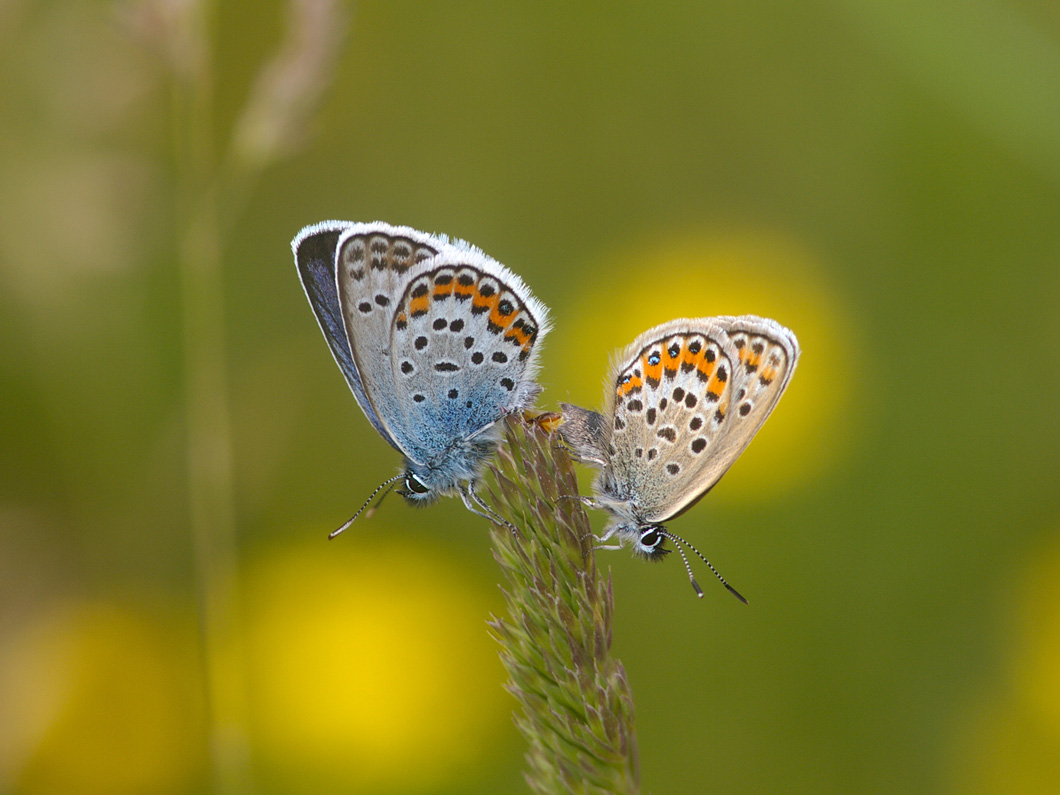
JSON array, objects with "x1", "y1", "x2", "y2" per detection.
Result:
[{"x1": 337, "y1": 225, "x2": 547, "y2": 464}]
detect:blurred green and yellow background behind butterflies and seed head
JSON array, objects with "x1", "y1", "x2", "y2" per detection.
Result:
[{"x1": 0, "y1": 0, "x2": 1060, "y2": 793}]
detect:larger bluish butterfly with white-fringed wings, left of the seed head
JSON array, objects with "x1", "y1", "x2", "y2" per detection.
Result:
[{"x1": 292, "y1": 220, "x2": 549, "y2": 537}]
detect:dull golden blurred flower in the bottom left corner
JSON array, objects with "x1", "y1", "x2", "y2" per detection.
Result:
[{"x1": 0, "y1": 603, "x2": 206, "y2": 794}]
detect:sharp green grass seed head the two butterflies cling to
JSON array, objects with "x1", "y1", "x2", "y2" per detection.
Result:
[{"x1": 490, "y1": 417, "x2": 639, "y2": 795}]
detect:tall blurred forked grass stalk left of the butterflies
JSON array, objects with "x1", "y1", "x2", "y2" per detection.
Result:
[{"x1": 147, "y1": 0, "x2": 347, "y2": 793}]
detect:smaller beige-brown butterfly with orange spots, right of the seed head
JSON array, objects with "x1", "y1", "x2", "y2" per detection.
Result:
[{"x1": 560, "y1": 315, "x2": 799, "y2": 601}]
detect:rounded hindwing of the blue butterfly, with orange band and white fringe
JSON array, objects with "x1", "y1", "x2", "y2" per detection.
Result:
[{"x1": 389, "y1": 253, "x2": 548, "y2": 463}]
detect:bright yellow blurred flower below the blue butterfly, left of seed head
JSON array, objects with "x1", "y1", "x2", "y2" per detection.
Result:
[{"x1": 247, "y1": 538, "x2": 513, "y2": 792}]
